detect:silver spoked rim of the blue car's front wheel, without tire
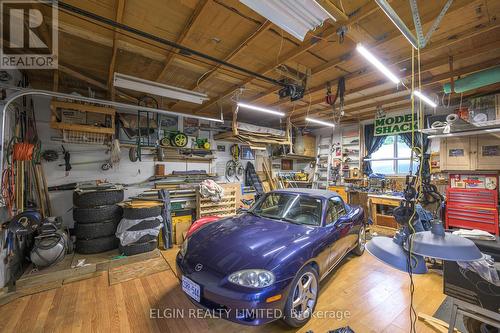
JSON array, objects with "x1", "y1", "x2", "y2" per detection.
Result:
[{"x1": 292, "y1": 272, "x2": 318, "y2": 321}]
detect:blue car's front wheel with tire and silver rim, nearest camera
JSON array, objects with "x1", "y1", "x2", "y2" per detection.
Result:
[{"x1": 283, "y1": 266, "x2": 319, "y2": 327}]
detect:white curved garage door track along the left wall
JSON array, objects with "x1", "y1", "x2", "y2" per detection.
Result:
[{"x1": 0, "y1": 89, "x2": 224, "y2": 176}]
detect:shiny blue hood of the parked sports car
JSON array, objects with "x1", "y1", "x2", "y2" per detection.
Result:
[{"x1": 186, "y1": 214, "x2": 315, "y2": 275}]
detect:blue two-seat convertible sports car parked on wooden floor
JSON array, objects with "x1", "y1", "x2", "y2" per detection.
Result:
[{"x1": 176, "y1": 189, "x2": 365, "y2": 327}]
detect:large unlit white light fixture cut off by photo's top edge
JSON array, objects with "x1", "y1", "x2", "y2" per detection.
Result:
[{"x1": 240, "y1": 0, "x2": 336, "y2": 41}]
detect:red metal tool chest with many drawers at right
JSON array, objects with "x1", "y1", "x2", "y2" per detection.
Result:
[{"x1": 446, "y1": 174, "x2": 499, "y2": 236}]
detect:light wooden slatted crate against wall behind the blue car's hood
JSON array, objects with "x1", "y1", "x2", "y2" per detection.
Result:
[{"x1": 196, "y1": 183, "x2": 241, "y2": 218}]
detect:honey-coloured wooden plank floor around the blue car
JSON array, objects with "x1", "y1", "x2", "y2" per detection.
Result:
[{"x1": 0, "y1": 250, "x2": 444, "y2": 333}]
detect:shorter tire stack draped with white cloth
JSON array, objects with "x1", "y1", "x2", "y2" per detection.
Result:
[{"x1": 118, "y1": 206, "x2": 163, "y2": 256}]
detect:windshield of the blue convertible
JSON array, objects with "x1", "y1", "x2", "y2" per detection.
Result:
[{"x1": 250, "y1": 193, "x2": 322, "y2": 226}]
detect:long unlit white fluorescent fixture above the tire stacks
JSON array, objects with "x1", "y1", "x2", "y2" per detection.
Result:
[{"x1": 113, "y1": 73, "x2": 208, "y2": 104}]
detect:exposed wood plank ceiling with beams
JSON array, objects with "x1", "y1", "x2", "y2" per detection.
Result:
[{"x1": 27, "y1": 0, "x2": 500, "y2": 125}]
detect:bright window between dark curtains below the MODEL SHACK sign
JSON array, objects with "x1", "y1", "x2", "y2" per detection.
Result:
[{"x1": 371, "y1": 135, "x2": 418, "y2": 175}]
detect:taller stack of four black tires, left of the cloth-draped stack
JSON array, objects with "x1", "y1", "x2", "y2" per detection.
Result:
[{"x1": 73, "y1": 189, "x2": 123, "y2": 254}]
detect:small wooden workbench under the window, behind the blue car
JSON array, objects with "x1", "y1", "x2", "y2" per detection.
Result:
[{"x1": 368, "y1": 194, "x2": 403, "y2": 231}]
